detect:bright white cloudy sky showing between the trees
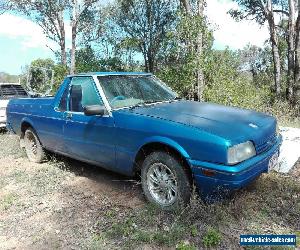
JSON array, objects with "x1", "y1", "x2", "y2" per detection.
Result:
[{"x1": 0, "y1": 0, "x2": 268, "y2": 74}]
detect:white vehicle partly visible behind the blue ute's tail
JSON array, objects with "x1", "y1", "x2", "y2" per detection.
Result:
[{"x1": 0, "y1": 83, "x2": 28, "y2": 128}]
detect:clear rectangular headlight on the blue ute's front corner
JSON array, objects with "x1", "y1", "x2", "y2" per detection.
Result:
[{"x1": 227, "y1": 141, "x2": 256, "y2": 165}]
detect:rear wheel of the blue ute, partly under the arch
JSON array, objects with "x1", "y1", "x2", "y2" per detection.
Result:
[{"x1": 24, "y1": 128, "x2": 46, "y2": 163}]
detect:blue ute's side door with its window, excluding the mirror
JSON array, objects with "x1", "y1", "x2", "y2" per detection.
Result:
[{"x1": 64, "y1": 76, "x2": 115, "y2": 168}]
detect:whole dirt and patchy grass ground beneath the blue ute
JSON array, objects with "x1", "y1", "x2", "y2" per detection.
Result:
[{"x1": 0, "y1": 133, "x2": 300, "y2": 250}]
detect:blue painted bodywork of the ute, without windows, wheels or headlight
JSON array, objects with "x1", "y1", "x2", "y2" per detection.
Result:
[{"x1": 7, "y1": 72, "x2": 282, "y2": 199}]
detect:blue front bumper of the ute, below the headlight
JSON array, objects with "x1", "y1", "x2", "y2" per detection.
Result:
[{"x1": 189, "y1": 135, "x2": 282, "y2": 199}]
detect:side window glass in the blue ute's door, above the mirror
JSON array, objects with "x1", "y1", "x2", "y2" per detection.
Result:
[{"x1": 69, "y1": 77, "x2": 103, "y2": 112}]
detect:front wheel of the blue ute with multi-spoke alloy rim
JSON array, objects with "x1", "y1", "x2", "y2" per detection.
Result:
[{"x1": 141, "y1": 151, "x2": 191, "y2": 210}]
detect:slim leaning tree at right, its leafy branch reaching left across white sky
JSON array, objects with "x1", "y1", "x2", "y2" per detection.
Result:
[{"x1": 230, "y1": 0, "x2": 286, "y2": 96}]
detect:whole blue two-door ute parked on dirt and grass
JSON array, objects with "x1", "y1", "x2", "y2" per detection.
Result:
[{"x1": 7, "y1": 72, "x2": 282, "y2": 209}]
